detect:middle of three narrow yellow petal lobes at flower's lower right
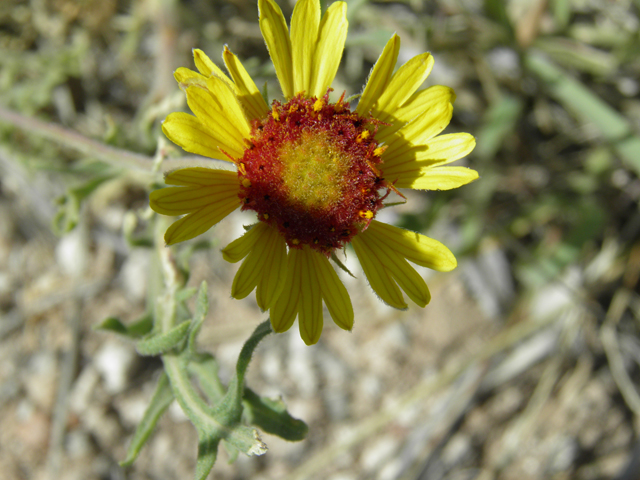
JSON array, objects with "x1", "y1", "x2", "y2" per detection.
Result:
[{"x1": 363, "y1": 231, "x2": 431, "y2": 307}]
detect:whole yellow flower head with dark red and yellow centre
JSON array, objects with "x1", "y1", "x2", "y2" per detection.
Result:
[{"x1": 150, "y1": 0, "x2": 478, "y2": 344}]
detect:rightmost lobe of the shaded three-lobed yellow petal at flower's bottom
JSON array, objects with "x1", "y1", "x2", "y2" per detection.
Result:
[{"x1": 311, "y1": 252, "x2": 353, "y2": 330}]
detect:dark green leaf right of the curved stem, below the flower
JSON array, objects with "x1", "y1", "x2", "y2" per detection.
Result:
[{"x1": 244, "y1": 388, "x2": 309, "y2": 442}]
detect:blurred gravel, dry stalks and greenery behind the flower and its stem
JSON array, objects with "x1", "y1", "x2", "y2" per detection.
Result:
[{"x1": 0, "y1": 0, "x2": 640, "y2": 480}]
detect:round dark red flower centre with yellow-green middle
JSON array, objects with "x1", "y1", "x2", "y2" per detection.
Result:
[{"x1": 238, "y1": 93, "x2": 393, "y2": 256}]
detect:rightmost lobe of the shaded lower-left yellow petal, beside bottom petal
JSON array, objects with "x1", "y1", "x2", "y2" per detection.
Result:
[{"x1": 256, "y1": 228, "x2": 287, "y2": 311}]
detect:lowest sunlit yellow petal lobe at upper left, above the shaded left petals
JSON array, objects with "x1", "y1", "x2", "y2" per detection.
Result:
[{"x1": 162, "y1": 112, "x2": 235, "y2": 161}]
